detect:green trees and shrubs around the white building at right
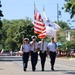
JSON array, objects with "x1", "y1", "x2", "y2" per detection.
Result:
[{"x1": 54, "y1": 21, "x2": 75, "y2": 50}]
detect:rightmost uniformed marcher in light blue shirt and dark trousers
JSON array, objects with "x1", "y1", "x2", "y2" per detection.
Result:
[{"x1": 48, "y1": 37, "x2": 58, "y2": 71}]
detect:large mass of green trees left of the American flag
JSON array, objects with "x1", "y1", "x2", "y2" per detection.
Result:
[{"x1": 0, "y1": 18, "x2": 34, "y2": 51}]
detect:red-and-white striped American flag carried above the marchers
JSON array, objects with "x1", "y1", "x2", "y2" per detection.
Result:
[{"x1": 34, "y1": 9, "x2": 46, "y2": 34}]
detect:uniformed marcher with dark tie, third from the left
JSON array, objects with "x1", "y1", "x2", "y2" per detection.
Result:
[{"x1": 38, "y1": 39, "x2": 47, "y2": 71}]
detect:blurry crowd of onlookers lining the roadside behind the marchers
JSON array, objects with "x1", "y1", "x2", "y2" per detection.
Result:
[{"x1": 0, "y1": 50, "x2": 75, "y2": 57}]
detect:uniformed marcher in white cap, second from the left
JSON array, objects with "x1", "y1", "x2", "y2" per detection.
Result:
[{"x1": 30, "y1": 36, "x2": 38, "y2": 71}]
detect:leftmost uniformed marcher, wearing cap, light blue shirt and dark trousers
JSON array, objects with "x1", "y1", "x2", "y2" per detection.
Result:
[{"x1": 21, "y1": 38, "x2": 30, "y2": 71}]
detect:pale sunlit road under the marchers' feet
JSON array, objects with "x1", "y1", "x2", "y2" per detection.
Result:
[{"x1": 0, "y1": 58, "x2": 75, "y2": 75}]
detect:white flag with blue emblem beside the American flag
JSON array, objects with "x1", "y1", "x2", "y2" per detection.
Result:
[{"x1": 43, "y1": 11, "x2": 60, "y2": 40}]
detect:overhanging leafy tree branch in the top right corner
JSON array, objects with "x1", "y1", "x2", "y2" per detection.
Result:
[{"x1": 64, "y1": 0, "x2": 75, "y2": 18}]
